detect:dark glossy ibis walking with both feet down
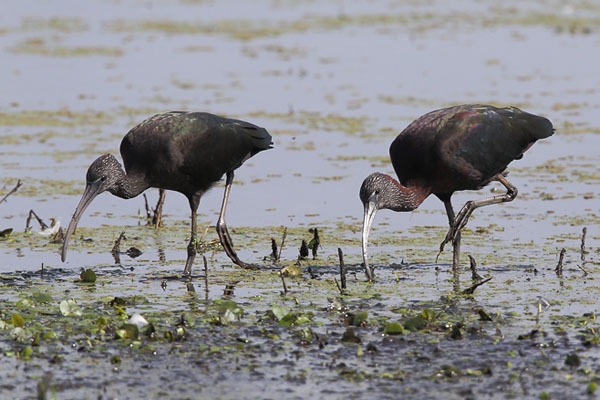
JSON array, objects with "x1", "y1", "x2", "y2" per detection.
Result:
[{"x1": 62, "y1": 111, "x2": 272, "y2": 275}]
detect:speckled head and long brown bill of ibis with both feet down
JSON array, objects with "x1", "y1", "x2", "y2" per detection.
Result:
[{"x1": 61, "y1": 154, "x2": 124, "y2": 261}]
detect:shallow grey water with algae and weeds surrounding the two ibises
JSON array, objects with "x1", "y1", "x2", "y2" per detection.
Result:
[{"x1": 0, "y1": 0, "x2": 600, "y2": 398}]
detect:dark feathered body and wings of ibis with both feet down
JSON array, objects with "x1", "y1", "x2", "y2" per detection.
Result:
[{"x1": 120, "y1": 111, "x2": 272, "y2": 196}]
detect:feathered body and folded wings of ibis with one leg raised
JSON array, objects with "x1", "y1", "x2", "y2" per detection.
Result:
[{"x1": 390, "y1": 105, "x2": 554, "y2": 195}]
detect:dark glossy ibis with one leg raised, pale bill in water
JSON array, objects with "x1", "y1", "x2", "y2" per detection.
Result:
[{"x1": 360, "y1": 104, "x2": 554, "y2": 280}]
